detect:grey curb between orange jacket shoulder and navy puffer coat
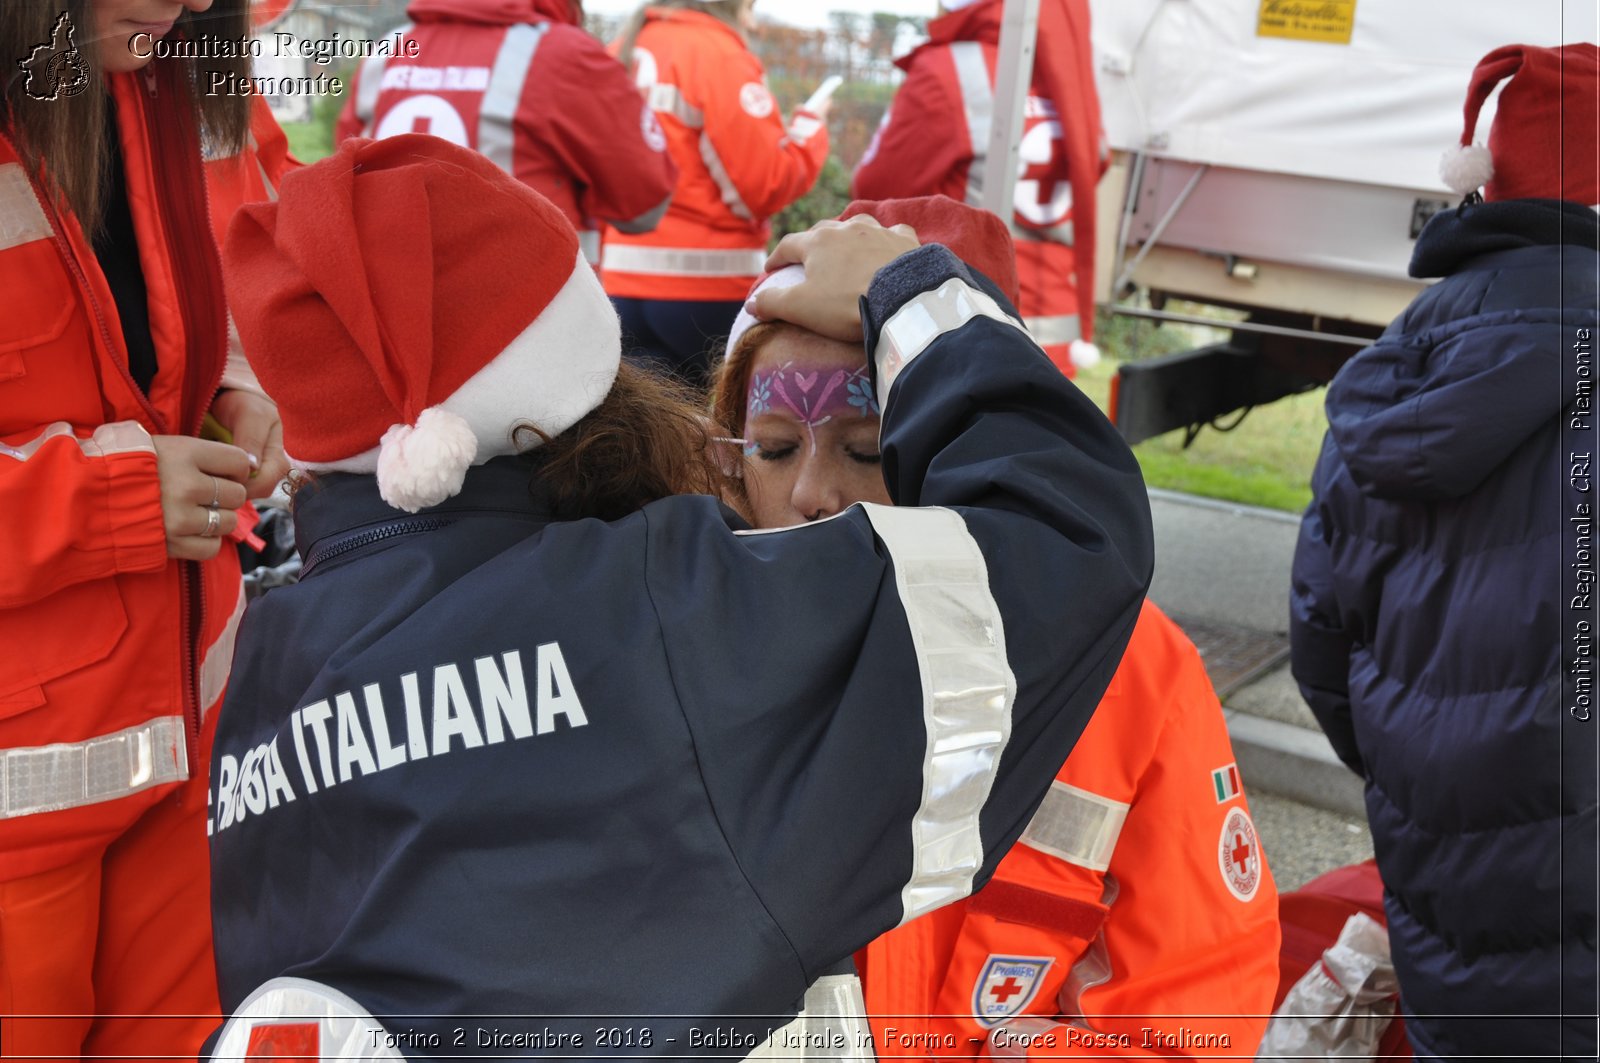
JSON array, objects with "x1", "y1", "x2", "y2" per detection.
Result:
[{"x1": 1227, "y1": 709, "x2": 1366, "y2": 823}]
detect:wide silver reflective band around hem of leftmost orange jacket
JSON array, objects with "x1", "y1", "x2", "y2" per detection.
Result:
[{"x1": 0, "y1": 716, "x2": 189, "y2": 820}]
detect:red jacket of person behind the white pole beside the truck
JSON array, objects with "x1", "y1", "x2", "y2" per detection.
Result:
[{"x1": 850, "y1": 0, "x2": 1104, "y2": 373}]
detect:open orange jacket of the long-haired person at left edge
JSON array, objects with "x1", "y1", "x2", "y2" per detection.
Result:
[{"x1": 0, "y1": 64, "x2": 288, "y2": 880}]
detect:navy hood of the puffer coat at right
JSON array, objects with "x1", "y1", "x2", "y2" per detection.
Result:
[{"x1": 1326, "y1": 200, "x2": 1600, "y2": 501}]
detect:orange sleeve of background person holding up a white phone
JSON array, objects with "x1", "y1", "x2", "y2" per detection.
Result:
[{"x1": 701, "y1": 53, "x2": 829, "y2": 223}]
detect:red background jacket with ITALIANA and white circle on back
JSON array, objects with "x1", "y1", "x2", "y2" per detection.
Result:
[{"x1": 338, "y1": 0, "x2": 678, "y2": 264}]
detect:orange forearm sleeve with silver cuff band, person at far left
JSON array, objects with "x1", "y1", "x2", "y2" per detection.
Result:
[{"x1": 0, "y1": 421, "x2": 166, "y2": 608}]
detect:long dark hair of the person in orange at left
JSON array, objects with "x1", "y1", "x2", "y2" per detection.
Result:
[{"x1": 0, "y1": 0, "x2": 250, "y2": 234}]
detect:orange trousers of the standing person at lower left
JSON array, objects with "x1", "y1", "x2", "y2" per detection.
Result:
[{"x1": 0, "y1": 772, "x2": 221, "y2": 1063}]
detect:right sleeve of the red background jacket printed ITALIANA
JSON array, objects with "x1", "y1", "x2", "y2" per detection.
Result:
[{"x1": 518, "y1": 26, "x2": 678, "y2": 224}]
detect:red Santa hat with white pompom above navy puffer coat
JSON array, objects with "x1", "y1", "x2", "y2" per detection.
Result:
[{"x1": 1438, "y1": 43, "x2": 1600, "y2": 207}]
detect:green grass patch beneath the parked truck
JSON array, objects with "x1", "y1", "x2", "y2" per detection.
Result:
[{"x1": 1077, "y1": 359, "x2": 1328, "y2": 512}]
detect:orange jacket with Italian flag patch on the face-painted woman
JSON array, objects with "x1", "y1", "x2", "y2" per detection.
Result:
[{"x1": 856, "y1": 602, "x2": 1278, "y2": 1058}]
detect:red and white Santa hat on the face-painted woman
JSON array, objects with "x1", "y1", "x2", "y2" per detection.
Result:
[{"x1": 728, "y1": 195, "x2": 1021, "y2": 354}]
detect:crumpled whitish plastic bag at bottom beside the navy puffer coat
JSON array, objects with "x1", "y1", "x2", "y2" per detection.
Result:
[{"x1": 1256, "y1": 913, "x2": 1400, "y2": 1063}]
